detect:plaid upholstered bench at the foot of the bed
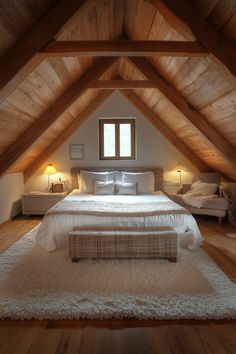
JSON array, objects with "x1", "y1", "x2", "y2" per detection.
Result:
[{"x1": 69, "y1": 226, "x2": 179, "y2": 262}]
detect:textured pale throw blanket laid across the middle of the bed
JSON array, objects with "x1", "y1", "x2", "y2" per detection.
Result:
[{"x1": 46, "y1": 200, "x2": 190, "y2": 217}]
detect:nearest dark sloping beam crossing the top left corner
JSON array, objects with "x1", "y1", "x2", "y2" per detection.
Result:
[{"x1": 0, "y1": 0, "x2": 86, "y2": 102}]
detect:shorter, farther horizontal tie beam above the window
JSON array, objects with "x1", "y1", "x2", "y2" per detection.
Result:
[{"x1": 90, "y1": 79, "x2": 156, "y2": 90}]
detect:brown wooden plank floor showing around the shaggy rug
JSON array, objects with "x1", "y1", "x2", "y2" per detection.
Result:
[{"x1": 0, "y1": 218, "x2": 236, "y2": 354}]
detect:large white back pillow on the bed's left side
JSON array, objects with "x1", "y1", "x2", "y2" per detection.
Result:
[{"x1": 79, "y1": 171, "x2": 114, "y2": 193}]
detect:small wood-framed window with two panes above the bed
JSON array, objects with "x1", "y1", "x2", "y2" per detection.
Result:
[{"x1": 99, "y1": 119, "x2": 135, "y2": 160}]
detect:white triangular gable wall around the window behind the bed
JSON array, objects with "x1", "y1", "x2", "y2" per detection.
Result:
[{"x1": 25, "y1": 91, "x2": 196, "y2": 190}]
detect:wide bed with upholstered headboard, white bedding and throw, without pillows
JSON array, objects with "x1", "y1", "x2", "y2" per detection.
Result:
[{"x1": 36, "y1": 168, "x2": 202, "y2": 252}]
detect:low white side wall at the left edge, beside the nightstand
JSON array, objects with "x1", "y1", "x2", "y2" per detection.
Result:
[{"x1": 0, "y1": 172, "x2": 24, "y2": 223}]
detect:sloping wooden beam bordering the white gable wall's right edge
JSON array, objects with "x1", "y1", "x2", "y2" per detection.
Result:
[{"x1": 120, "y1": 90, "x2": 210, "y2": 172}]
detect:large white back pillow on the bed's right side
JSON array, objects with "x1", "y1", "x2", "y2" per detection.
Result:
[{"x1": 122, "y1": 171, "x2": 154, "y2": 194}]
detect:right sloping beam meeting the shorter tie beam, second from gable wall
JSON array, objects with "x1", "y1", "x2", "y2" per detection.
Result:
[{"x1": 129, "y1": 57, "x2": 236, "y2": 166}]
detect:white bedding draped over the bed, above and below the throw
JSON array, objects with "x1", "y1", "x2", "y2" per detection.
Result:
[{"x1": 36, "y1": 190, "x2": 202, "y2": 252}]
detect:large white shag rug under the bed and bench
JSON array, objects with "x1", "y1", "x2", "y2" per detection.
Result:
[{"x1": 0, "y1": 228, "x2": 236, "y2": 320}]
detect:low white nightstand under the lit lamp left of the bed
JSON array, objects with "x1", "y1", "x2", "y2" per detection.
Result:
[{"x1": 22, "y1": 192, "x2": 68, "y2": 215}]
